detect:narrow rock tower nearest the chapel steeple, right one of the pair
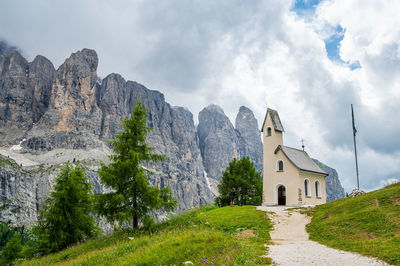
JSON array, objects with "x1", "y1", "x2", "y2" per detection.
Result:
[{"x1": 235, "y1": 106, "x2": 263, "y2": 171}]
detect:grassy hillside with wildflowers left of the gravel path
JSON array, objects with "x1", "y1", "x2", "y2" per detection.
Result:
[{"x1": 20, "y1": 206, "x2": 272, "y2": 265}]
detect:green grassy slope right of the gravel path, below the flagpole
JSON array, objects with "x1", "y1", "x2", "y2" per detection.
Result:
[{"x1": 307, "y1": 183, "x2": 400, "y2": 265}]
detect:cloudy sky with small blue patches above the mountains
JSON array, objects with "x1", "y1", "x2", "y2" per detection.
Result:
[{"x1": 0, "y1": 0, "x2": 400, "y2": 191}]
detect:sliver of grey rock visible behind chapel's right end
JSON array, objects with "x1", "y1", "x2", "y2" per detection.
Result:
[{"x1": 313, "y1": 159, "x2": 345, "y2": 202}]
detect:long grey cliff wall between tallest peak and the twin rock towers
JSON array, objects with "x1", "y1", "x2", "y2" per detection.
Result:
[{"x1": 99, "y1": 74, "x2": 212, "y2": 210}]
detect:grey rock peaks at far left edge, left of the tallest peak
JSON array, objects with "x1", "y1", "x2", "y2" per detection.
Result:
[{"x1": 0, "y1": 50, "x2": 55, "y2": 145}]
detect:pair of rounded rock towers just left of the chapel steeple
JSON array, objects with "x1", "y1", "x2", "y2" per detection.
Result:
[{"x1": 197, "y1": 105, "x2": 262, "y2": 183}]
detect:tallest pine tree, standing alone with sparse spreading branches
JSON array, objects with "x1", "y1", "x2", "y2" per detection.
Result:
[{"x1": 96, "y1": 102, "x2": 177, "y2": 229}]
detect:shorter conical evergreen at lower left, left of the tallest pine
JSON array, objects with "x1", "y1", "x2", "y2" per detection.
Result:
[{"x1": 33, "y1": 163, "x2": 98, "y2": 254}]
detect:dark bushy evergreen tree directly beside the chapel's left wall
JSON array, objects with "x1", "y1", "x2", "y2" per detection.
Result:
[{"x1": 215, "y1": 157, "x2": 262, "y2": 206}]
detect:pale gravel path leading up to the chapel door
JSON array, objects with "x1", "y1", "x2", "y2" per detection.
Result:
[{"x1": 257, "y1": 206, "x2": 389, "y2": 266}]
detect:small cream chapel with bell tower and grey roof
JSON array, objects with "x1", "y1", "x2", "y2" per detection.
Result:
[{"x1": 261, "y1": 108, "x2": 328, "y2": 206}]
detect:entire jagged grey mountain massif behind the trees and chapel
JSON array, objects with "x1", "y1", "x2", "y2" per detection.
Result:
[{"x1": 0, "y1": 49, "x2": 344, "y2": 225}]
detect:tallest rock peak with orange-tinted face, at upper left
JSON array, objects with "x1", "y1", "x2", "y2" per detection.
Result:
[{"x1": 45, "y1": 49, "x2": 101, "y2": 133}]
